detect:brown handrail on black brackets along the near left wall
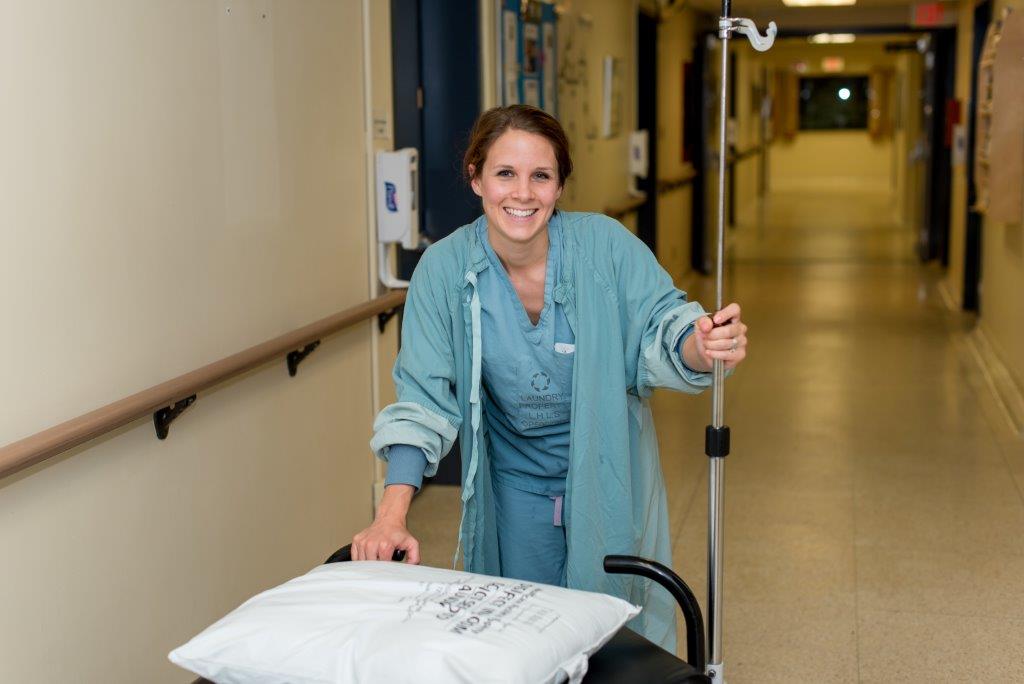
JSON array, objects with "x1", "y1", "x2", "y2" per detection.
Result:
[{"x1": 0, "y1": 290, "x2": 406, "y2": 478}]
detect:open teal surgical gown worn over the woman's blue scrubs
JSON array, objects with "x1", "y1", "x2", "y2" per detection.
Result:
[{"x1": 371, "y1": 211, "x2": 711, "y2": 653}]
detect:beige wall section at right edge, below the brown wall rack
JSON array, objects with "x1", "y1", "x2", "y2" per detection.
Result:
[{"x1": 980, "y1": 0, "x2": 1024, "y2": 389}]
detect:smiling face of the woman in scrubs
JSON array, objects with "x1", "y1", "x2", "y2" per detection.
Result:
[{"x1": 470, "y1": 129, "x2": 562, "y2": 244}]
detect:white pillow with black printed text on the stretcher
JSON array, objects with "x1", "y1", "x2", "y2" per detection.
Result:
[{"x1": 170, "y1": 561, "x2": 640, "y2": 684}]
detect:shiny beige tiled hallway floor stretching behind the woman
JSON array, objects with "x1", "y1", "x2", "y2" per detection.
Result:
[{"x1": 411, "y1": 188, "x2": 1024, "y2": 684}]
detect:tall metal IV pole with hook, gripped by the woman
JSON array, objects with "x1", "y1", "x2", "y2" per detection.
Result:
[{"x1": 705, "y1": 0, "x2": 777, "y2": 684}]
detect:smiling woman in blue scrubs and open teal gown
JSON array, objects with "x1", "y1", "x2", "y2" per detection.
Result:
[{"x1": 352, "y1": 105, "x2": 746, "y2": 652}]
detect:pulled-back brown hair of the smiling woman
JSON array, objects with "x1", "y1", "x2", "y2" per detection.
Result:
[{"x1": 462, "y1": 104, "x2": 572, "y2": 187}]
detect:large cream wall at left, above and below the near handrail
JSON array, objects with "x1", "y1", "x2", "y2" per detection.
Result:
[{"x1": 0, "y1": 0, "x2": 394, "y2": 682}]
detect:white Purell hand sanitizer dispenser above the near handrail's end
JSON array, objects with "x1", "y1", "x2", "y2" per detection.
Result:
[{"x1": 377, "y1": 147, "x2": 420, "y2": 288}]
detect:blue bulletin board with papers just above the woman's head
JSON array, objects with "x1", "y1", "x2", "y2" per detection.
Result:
[{"x1": 499, "y1": 0, "x2": 558, "y2": 116}]
